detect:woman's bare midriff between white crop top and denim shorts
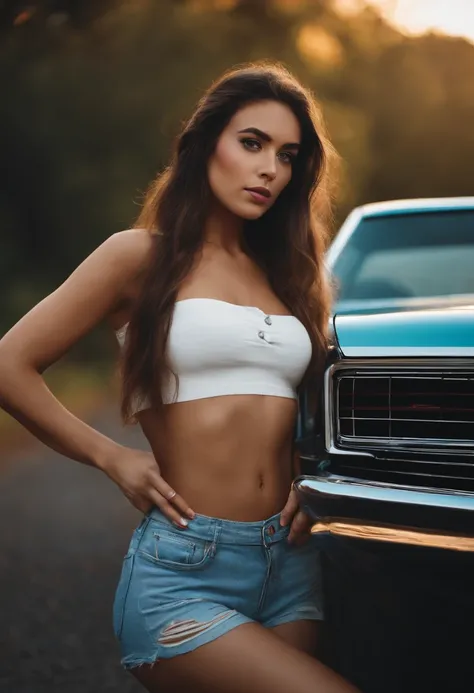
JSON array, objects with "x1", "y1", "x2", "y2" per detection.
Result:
[{"x1": 138, "y1": 395, "x2": 297, "y2": 522}]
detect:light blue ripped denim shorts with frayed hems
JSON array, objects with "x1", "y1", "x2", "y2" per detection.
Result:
[{"x1": 113, "y1": 508, "x2": 323, "y2": 668}]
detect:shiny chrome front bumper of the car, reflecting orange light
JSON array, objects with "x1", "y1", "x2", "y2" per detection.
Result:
[{"x1": 294, "y1": 475, "x2": 474, "y2": 552}]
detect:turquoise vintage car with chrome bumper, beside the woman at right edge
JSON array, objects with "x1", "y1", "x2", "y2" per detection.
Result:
[{"x1": 295, "y1": 198, "x2": 474, "y2": 551}]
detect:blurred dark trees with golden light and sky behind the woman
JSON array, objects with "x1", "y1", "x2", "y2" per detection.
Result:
[{"x1": 0, "y1": 0, "x2": 474, "y2": 452}]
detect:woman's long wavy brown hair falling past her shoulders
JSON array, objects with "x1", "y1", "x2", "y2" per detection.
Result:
[{"x1": 121, "y1": 62, "x2": 335, "y2": 422}]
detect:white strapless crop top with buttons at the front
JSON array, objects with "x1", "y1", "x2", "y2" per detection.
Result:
[{"x1": 116, "y1": 298, "x2": 311, "y2": 413}]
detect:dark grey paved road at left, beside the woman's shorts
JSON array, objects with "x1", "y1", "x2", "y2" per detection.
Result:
[{"x1": 0, "y1": 408, "x2": 145, "y2": 693}]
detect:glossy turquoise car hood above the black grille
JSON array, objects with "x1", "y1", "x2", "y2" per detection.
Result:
[{"x1": 333, "y1": 297, "x2": 474, "y2": 358}]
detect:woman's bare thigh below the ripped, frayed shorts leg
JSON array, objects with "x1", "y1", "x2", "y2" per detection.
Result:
[{"x1": 131, "y1": 623, "x2": 357, "y2": 693}]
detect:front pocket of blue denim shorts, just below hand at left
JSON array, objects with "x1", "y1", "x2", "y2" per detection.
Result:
[{"x1": 138, "y1": 525, "x2": 215, "y2": 570}]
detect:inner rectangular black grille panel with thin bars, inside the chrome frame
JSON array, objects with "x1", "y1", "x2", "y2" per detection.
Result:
[{"x1": 334, "y1": 370, "x2": 474, "y2": 451}]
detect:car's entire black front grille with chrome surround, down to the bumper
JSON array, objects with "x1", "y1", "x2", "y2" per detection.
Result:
[{"x1": 327, "y1": 360, "x2": 474, "y2": 494}]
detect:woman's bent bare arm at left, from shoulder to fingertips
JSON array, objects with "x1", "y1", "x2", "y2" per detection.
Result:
[{"x1": 0, "y1": 229, "x2": 192, "y2": 522}]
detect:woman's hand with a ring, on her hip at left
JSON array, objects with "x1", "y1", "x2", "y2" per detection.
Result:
[{"x1": 104, "y1": 447, "x2": 194, "y2": 528}]
